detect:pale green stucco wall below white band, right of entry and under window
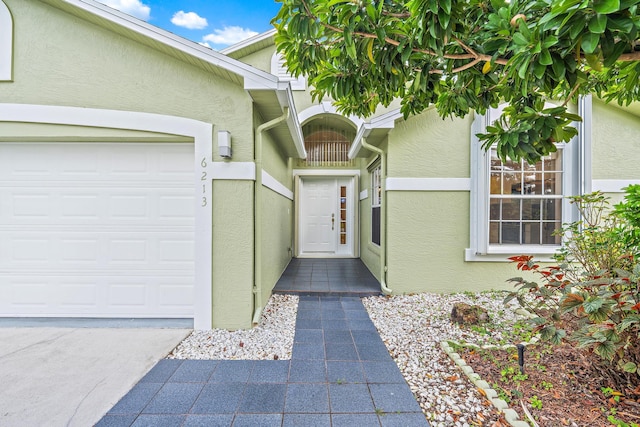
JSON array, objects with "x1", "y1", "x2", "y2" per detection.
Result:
[{"x1": 387, "y1": 191, "x2": 518, "y2": 294}]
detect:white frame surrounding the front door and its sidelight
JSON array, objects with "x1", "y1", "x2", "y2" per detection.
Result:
[{"x1": 293, "y1": 169, "x2": 360, "y2": 258}]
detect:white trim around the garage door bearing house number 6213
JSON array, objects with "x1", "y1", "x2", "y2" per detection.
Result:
[{"x1": 0, "y1": 103, "x2": 215, "y2": 329}]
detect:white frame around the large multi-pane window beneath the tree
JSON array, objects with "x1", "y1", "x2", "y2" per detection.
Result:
[{"x1": 465, "y1": 105, "x2": 587, "y2": 262}]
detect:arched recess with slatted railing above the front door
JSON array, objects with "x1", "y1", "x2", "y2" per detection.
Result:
[{"x1": 300, "y1": 122, "x2": 356, "y2": 167}]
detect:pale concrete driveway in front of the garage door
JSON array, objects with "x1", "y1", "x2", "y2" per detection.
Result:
[{"x1": 0, "y1": 327, "x2": 191, "y2": 427}]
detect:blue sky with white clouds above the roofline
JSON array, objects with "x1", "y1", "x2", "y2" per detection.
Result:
[{"x1": 97, "y1": 0, "x2": 280, "y2": 49}]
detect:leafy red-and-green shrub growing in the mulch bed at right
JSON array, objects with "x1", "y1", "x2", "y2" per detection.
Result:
[{"x1": 505, "y1": 191, "x2": 640, "y2": 388}]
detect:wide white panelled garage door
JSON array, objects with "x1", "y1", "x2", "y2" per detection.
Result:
[{"x1": 0, "y1": 142, "x2": 195, "y2": 317}]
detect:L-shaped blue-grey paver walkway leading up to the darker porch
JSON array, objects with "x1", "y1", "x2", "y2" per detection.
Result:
[{"x1": 98, "y1": 296, "x2": 429, "y2": 427}]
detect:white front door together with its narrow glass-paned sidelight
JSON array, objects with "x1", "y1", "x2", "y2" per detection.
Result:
[{"x1": 298, "y1": 177, "x2": 355, "y2": 257}]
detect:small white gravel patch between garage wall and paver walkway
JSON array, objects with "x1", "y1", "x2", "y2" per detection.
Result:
[{"x1": 167, "y1": 295, "x2": 298, "y2": 360}]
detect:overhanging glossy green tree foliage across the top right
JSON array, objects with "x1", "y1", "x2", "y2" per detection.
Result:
[{"x1": 273, "y1": 0, "x2": 640, "y2": 162}]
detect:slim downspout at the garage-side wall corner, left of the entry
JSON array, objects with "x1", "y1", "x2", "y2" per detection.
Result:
[{"x1": 252, "y1": 107, "x2": 289, "y2": 325}]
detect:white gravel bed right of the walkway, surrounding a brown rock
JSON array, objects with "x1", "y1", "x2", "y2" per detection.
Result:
[{"x1": 363, "y1": 292, "x2": 519, "y2": 427}]
